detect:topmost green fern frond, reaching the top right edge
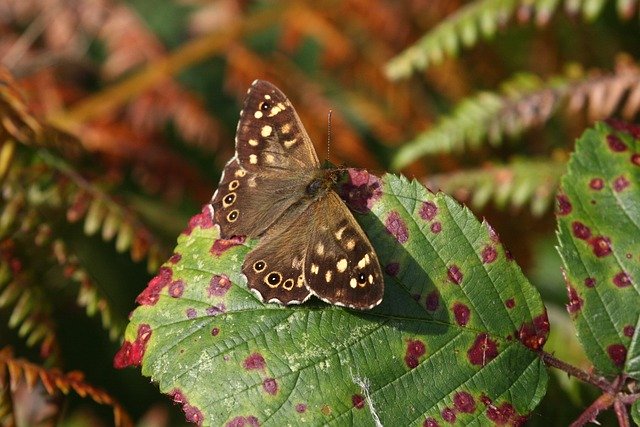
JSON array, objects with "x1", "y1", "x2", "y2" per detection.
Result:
[{"x1": 385, "y1": 0, "x2": 638, "y2": 80}]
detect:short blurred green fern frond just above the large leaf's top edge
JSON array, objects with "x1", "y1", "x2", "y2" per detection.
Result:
[{"x1": 423, "y1": 159, "x2": 565, "y2": 216}]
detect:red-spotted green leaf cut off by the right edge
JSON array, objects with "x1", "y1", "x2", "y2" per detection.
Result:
[{"x1": 558, "y1": 123, "x2": 640, "y2": 379}]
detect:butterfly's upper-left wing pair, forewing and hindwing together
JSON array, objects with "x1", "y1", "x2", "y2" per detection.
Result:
[{"x1": 211, "y1": 80, "x2": 320, "y2": 238}]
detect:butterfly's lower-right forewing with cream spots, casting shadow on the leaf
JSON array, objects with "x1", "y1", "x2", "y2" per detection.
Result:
[{"x1": 304, "y1": 191, "x2": 384, "y2": 309}]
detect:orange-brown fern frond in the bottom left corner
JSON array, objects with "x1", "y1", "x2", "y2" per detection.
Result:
[{"x1": 0, "y1": 348, "x2": 133, "y2": 427}]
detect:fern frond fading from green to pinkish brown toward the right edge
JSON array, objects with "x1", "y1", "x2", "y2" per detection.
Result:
[{"x1": 392, "y1": 60, "x2": 640, "y2": 169}]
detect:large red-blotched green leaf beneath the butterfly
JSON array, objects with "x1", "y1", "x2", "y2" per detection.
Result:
[{"x1": 114, "y1": 175, "x2": 549, "y2": 426}]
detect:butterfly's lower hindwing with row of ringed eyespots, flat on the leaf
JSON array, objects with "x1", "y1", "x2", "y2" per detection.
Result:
[{"x1": 242, "y1": 215, "x2": 311, "y2": 304}]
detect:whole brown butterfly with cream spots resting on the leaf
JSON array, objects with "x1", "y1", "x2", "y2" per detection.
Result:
[{"x1": 211, "y1": 80, "x2": 384, "y2": 309}]
